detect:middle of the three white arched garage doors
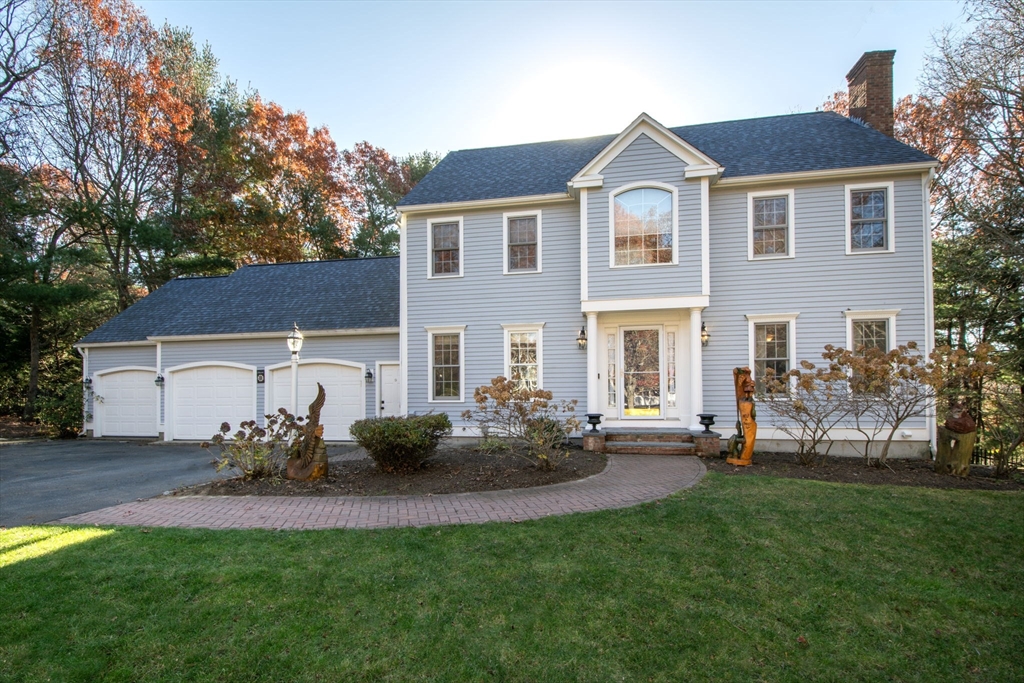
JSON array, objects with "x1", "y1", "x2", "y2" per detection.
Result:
[{"x1": 171, "y1": 366, "x2": 256, "y2": 441}]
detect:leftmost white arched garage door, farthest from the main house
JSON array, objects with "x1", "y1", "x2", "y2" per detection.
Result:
[{"x1": 95, "y1": 370, "x2": 157, "y2": 436}]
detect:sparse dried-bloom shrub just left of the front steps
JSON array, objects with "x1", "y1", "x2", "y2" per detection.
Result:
[{"x1": 462, "y1": 377, "x2": 580, "y2": 470}]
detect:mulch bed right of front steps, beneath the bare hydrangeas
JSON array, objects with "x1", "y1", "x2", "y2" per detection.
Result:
[{"x1": 703, "y1": 453, "x2": 1024, "y2": 490}]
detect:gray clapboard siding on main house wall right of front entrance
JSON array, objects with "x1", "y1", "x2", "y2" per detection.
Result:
[{"x1": 703, "y1": 175, "x2": 928, "y2": 428}]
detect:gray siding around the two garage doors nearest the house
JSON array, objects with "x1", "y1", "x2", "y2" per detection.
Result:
[{"x1": 161, "y1": 334, "x2": 398, "y2": 428}]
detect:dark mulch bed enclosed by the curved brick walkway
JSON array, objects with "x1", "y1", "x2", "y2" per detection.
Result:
[{"x1": 174, "y1": 447, "x2": 607, "y2": 497}]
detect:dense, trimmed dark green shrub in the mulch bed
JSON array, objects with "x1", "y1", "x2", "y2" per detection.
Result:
[{"x1": 348, "y1": 413, "x2": 452, "y2": 473}]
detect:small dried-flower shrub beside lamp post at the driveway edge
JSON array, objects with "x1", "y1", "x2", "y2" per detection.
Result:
[{"x1": 202, "y1": 408, "x2": 302, "y2": 479}]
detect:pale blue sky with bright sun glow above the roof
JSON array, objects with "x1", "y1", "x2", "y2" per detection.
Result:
[{"x1": 137, "y1": 0, "x2": 963, "y2": 155}]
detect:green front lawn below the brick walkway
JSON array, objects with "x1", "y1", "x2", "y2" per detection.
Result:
[{"x1": 0, "y1": 473, "x2": 1024, "y2": 682}]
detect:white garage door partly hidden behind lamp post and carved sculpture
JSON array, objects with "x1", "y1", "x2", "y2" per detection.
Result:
[{"x1": 266, "y1": 362, "x2": 366, "y2": 441}]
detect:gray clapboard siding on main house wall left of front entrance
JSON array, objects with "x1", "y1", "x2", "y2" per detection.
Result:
[{"x1": 406, "y1": 202, "x2": 587, "y2": 423}]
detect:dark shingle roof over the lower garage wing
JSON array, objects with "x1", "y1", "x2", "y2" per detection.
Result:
[{"x1": 80, "y1": 256, "x2": 399, "y2": 344}]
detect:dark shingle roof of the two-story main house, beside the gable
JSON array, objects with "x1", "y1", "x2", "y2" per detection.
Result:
[{"x1": 398, "y1": 112, "x2": 933, "y2": 206}]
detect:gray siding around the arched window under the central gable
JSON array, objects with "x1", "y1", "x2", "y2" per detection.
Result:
[{"x1": 587, "y1": 135, "x2": 700, "y2": 299}]
